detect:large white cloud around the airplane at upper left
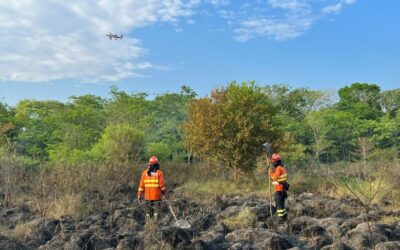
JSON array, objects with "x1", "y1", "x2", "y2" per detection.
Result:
[{"x1": 0, "y1": 0, "x2": 199, "y2": 82}]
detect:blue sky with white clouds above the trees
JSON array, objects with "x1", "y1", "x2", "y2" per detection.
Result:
[{"x1": 0, "y1": 0, "x2": 400, "y2": 105}]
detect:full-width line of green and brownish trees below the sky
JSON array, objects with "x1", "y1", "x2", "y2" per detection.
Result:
[{"x1": 0, "y1": 82, "x2": 400, "y2": 173}]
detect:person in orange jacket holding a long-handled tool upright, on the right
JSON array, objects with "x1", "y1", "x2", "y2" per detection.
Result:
[{"x1": 269, "y1": 153, "x2": 288, "y2": 222}]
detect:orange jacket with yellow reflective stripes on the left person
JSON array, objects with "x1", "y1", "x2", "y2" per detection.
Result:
[{"x1": 138, "y1": 169, "x2": 165, "y2": 201}]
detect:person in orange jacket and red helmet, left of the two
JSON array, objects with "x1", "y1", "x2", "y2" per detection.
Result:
[{"x1": 137, "y1": 156, "x2": 165, "y2": 219}]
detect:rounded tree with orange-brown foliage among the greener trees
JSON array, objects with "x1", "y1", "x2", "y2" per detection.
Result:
[{"x1": 183, "y1": 82, "x2": 282, "y2": 180}]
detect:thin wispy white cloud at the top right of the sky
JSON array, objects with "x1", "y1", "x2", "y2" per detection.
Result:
[{"x1": 234, "y1": 0, "x2": 356, "y2": 42}]
